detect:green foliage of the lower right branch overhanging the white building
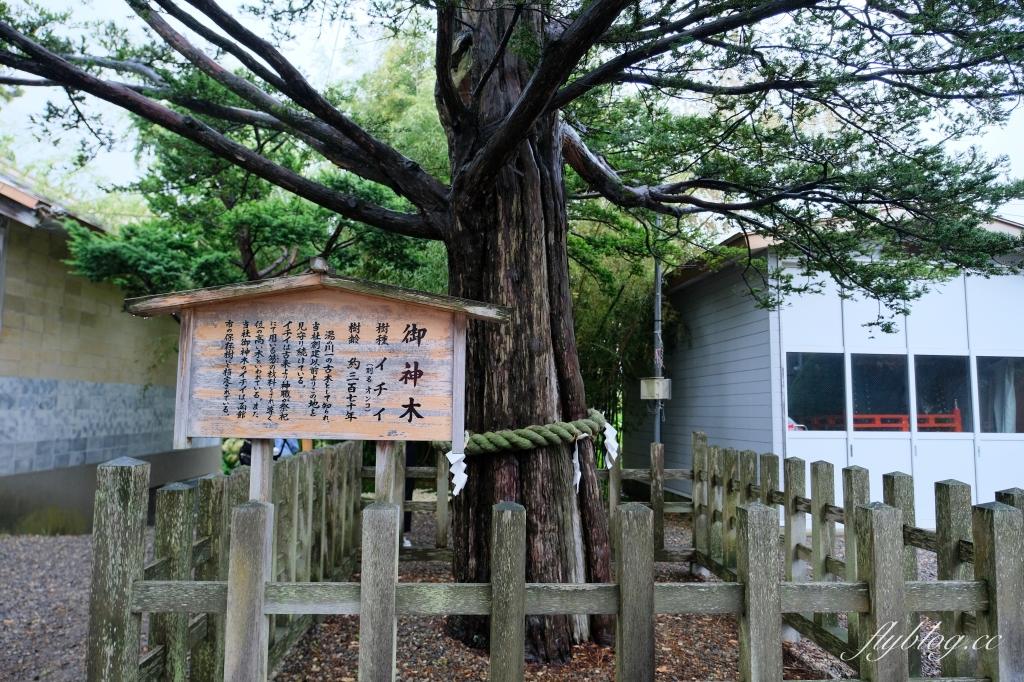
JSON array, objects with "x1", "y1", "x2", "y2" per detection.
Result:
[{"x1": 567, "y1": 82, "x2": 1024, "y2": 331}]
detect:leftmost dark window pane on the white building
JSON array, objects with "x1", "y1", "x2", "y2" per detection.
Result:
[{"x1": 785, "y1": 353, "x2": 846, "y2": 431}]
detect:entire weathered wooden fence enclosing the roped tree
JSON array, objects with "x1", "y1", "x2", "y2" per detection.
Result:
[{"x1": 89, "y1": 434, "x2": 1024, "y2": 682}]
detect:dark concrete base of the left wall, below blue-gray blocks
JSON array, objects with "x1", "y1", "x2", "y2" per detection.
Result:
[{"x1": 0, "y1": 445, "x2": 220, "y2": 532}]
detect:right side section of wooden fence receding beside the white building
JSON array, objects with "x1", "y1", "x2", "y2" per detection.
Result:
[{"x1": 691, "y1": 432, "x2": 1024, "y2": 680}]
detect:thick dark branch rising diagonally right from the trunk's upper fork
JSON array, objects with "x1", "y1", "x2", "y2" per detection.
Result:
[{"x1": 459, "y1": 0, "x2": 630, "y2": 188}]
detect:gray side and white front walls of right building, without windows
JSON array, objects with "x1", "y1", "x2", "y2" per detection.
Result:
[{"x1": 624, "y1": 262, "x2": 1024, "y2": 518}]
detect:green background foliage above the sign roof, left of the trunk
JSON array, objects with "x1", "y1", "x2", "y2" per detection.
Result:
[{"x1": 61, "y1": 33, "x2": 447, "y2": 296}]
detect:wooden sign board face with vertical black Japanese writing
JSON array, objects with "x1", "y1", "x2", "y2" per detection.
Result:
[{"x1": 199, "y1": 301, "x2": 451, "y2": 438}]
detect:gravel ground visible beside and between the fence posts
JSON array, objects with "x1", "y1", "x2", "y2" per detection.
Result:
[{"x1": 0, "y1": 499, "x2": 939, "y2": 682}]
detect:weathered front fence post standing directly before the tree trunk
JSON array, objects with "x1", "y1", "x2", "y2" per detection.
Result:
[{"x1": 489, "y1": 502, "x2": 526, "y2": 682}]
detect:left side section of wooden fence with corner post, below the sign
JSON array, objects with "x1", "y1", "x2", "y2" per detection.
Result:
[{"x1": 86, "y1": 442, "x2": 361, "y2": 682}]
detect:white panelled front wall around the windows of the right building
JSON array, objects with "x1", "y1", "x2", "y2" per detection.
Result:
[{"x1": 780, "y1": 276, "x2": 1024, "y2": 527}]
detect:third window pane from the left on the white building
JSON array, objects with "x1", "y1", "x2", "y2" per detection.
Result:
[{"x1": 913, "y1": 355, "x2": 974, "y2": 433}]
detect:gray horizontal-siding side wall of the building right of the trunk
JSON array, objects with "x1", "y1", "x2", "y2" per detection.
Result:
[{"x1": 624, "y1": 267, "x2": 782, "y2": 495}]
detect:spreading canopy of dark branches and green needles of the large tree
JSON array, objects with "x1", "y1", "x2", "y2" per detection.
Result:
[{"x1": 0, "y1": 0, "x2": 1024, "y2": 311}]
